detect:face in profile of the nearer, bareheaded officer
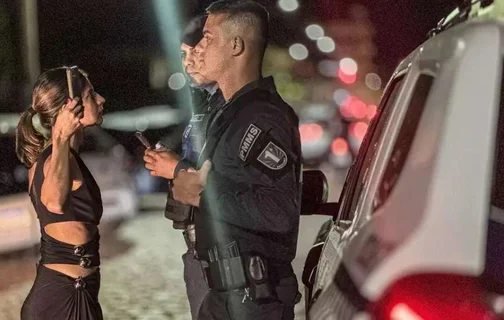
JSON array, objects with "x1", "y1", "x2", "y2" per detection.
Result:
[{"x1": 195, "y1": 14, "x2": 231, "y2": 82}]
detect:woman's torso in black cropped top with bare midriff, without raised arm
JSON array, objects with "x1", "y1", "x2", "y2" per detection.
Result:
[{"x1": 29, "y1": 145, "x2": 103, "y2": 277}]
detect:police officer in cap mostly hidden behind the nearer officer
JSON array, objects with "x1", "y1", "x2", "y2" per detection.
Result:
[{"x1": 144, "y1": 16, "x2": 223, "y2": 319}]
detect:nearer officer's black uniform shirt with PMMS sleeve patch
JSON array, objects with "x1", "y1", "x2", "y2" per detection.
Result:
[{"x1": 195, "y1": 77, "x2": 301, "y2": 268}]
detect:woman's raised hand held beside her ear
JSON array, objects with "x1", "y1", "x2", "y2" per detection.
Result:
[{"x1": 53, "y1": 98, "x2": 84, "y2": 141}]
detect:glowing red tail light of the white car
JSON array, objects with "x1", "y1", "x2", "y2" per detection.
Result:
[{"x1": 370, "y1": 274, "x2": 499, "y2": 320}]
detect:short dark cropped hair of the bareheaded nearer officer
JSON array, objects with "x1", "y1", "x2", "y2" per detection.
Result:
[{"x1": 206, "y1": 0, "x2": 269, "y2": 54}]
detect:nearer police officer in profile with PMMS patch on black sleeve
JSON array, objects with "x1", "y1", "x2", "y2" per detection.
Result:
[{"x1": 173, "y1": 0, "x2": 301, "y2": 319}]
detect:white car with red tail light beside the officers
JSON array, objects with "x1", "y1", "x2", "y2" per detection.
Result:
[{"x1": 303, "y1": 1, "x2": 504, "y2": 320}]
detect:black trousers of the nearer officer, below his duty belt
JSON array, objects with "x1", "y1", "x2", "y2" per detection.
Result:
[{"x1": 198, "y1": 277, "x2": 300, "y2": 320}]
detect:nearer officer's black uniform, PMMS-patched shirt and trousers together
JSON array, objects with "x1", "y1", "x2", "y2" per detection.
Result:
[{"x1": 195, "y1": 77, "x2": 301, "y2": 319}]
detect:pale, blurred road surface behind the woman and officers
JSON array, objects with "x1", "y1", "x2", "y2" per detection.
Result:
[{"x1": 0, "y1": 165, "x2": 342, "y2": 320}]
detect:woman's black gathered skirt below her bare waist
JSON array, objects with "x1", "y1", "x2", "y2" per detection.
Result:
[{"x1": 21, "y1": 265, "x2": 103, "y2": 320}]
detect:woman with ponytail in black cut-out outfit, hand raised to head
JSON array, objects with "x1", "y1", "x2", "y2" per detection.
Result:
[{"x1": 16, "y1": 67, "x2": 105, "y2": 320}]
